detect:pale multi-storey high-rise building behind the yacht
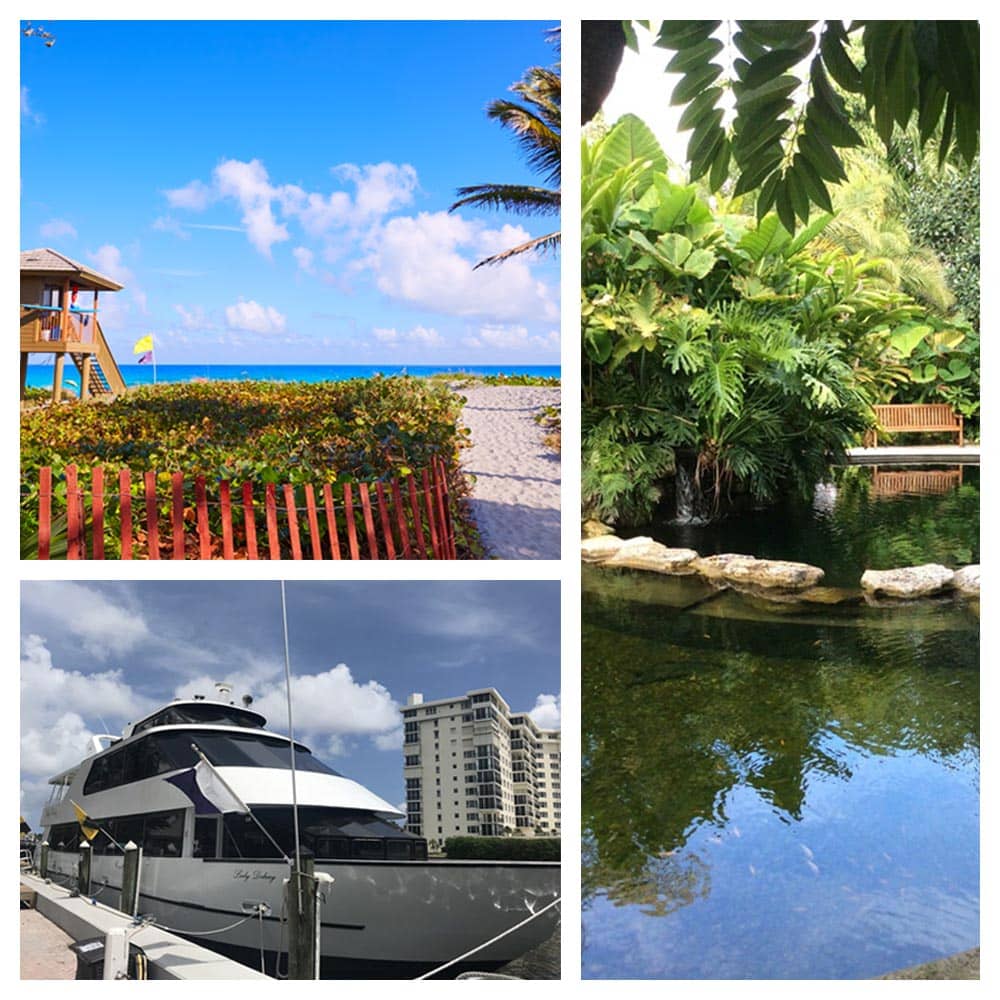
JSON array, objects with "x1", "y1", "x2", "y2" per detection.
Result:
[{"x1": 403, "y1": 688, "x2": 562, "y2": 841}]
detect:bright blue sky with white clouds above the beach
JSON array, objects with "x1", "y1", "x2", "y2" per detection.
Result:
[{"x1": 21, "y1": 21, "x2": 559, "y2": 364}]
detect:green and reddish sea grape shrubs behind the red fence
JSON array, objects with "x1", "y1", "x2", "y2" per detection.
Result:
[{"x1": 21, "y1": 376, "x2": 479, "y2": 555}]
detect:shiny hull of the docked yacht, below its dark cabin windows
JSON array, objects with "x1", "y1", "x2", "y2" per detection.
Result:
[{"x1": 43, "y1": 852, "x2": 560, "y2": 978}]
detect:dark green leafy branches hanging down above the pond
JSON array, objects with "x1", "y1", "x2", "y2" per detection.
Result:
[{"x1": 626, "y1": 20, "x2": 979, "y2": 231}]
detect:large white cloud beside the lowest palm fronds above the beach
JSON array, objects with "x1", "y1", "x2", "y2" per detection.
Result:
[{"x1": 363, "y1": 212, "x2": 558, "y2": 322}]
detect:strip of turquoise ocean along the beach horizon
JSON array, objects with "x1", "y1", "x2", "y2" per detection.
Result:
[{"x1": 27, "y1": 364, "x2": 560, "y2": 389}]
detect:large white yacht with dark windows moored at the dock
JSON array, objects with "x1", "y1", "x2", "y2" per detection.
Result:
[{"x1": 42, "y1": 691, "x2": 560, "y2": 978}]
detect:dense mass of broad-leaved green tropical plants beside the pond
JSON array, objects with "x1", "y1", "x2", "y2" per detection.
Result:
[{"x1": 581, "y1": 116, "x2": 968, "y2": 523}]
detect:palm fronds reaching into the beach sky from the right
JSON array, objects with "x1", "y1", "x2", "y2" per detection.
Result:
[{"x1": 448, "y1": 54, "x2": 562, "y2": 268}]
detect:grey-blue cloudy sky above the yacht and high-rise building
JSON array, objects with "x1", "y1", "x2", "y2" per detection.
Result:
[{"x1": 21, "y1": 580, "x2": 561, "y2": 827}]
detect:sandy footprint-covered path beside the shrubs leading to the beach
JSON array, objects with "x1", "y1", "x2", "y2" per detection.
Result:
[{"x1": 459, "y1": 386, "x2": 560, "y2": 559}]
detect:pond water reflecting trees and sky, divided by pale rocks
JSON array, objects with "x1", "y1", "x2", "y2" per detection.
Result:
[{"x1": 583, "y1": 470, "x2": 979, "y2": 979}]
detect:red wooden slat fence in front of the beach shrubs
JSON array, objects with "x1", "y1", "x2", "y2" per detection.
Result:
[{"x1": 26, "y1": 459, "x2": 457, "y2": 559}]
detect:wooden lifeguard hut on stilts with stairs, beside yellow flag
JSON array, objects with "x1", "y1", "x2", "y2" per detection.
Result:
[{"x1": 21, "y1": 248, "x2": 125, "y2": 402}]
